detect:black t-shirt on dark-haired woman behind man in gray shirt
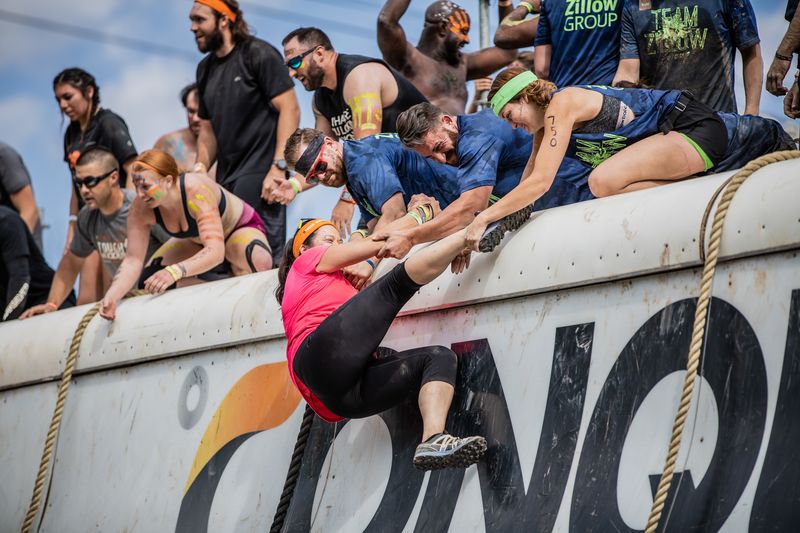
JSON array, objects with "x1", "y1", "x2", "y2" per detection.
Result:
[{"x1": 64, "y1": 108, "x2": 136, "y2": 196}]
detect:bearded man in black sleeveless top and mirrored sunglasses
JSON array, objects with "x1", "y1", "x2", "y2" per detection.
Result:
[{"x1": 283, "y1": 28, "x2": 426, "y2": 235}]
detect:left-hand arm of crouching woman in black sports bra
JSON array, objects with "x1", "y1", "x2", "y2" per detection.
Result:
[{"x1": 100, "y1": 197, "x2": 155, "y2": 320}]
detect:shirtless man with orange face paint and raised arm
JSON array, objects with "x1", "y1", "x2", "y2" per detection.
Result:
[{"x1": 378, "y1": 0, "x2": 517, "y2": 115}]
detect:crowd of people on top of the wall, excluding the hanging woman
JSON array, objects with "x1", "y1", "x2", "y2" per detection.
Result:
[{"x1": 0, "y1": 0, "x2": 800, "y2": 320}]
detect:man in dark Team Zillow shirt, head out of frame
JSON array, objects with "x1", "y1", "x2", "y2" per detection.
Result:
[{"x1": 614, "y1": 0, "x2": 764, "y2": 115}]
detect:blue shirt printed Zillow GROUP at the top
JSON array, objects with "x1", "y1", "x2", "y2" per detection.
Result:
[{"x1": 534, "y1": 0, "x2": 620, "y2": 87}]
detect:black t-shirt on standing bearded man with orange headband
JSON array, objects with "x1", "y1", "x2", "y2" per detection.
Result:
[{"x1": 197, "y1": 37, "x2": 294, "y2": 188}]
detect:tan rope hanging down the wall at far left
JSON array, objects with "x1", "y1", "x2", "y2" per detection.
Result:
[{"x1": 21, "y1": 290, "x2": 146, "y2": 533}]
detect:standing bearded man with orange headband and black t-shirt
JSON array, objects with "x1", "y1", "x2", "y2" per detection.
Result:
[{"x1": 189, "y1": 0, "x2": 300, "y2": 264}]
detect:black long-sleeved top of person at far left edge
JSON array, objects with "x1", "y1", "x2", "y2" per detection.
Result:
[{"x1": 0, "y1": 206, "x2": 75, "y2": 321}]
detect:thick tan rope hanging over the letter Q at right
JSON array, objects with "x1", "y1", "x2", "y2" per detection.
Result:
[{"x1": 645, "y1": 150, "x2": 800, "y2": 533}]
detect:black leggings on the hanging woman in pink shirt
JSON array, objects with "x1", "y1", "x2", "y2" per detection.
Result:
[{"x1": 293, "y1": 263, "x2": 458, "y2": 418}]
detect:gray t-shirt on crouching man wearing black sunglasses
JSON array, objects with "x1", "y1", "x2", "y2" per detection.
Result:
[{"x1": 69, "y1": 189, "x2": 169, "y2": 277}]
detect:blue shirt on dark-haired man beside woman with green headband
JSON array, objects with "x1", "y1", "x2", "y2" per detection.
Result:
[{"x1": 456, "y1": 109, "x2": 593, "y2": 210}]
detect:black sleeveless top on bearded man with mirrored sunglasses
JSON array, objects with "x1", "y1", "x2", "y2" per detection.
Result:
[{"x1": 314, "y1": 54, "x2": 427, "y2": 140}]
